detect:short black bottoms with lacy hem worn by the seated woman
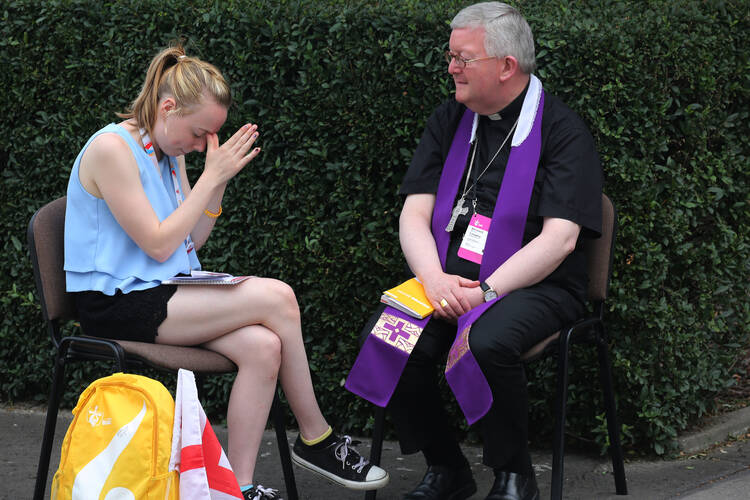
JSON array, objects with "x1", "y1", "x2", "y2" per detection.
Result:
[{"x1": 73, "y1": 285, "x2": 177, "y2": 343}]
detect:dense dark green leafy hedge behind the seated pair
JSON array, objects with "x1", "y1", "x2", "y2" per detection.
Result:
[{"x1": 0, "y1": 0, "x2": 750, "y2": 454}]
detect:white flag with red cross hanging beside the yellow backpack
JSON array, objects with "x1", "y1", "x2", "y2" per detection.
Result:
[{"x1": 169, "y1": 369, "x2": 242, "y2": 500}]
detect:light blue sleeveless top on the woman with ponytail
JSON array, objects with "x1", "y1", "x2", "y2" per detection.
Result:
[{"x1": 65, "y1": 123, "x2": 200, "y2": 295}]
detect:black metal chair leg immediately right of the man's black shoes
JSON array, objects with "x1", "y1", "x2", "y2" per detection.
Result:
[{"x1": 550, "y1": 330, "x2": 571, "y2": 500}]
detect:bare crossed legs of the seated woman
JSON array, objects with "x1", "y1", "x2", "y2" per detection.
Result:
[{"x1": 156, "y1": 278, "x2": 328, "y2": 484}]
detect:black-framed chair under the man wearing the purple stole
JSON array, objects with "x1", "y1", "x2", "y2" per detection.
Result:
[{"x1": 365, "y1": 194, "x2": 628, "y2": 500}]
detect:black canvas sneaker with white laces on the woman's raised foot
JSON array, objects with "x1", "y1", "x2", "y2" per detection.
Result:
[{"x1": 292, "y1": 436, "x2": 388, "y2": 490}]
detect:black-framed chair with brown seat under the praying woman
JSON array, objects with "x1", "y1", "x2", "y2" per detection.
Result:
[{"x1": 27, "y1": 197, "x2": 298, "y2": 500}]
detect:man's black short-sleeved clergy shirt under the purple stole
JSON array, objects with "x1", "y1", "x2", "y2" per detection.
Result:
[{"x1": 400, "y1": 85, "x2": 602, "y2": 300}]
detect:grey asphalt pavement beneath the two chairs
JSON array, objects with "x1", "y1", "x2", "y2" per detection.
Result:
[{"x1": 0, "y1": 404, "x2": 750, "y2": 500}]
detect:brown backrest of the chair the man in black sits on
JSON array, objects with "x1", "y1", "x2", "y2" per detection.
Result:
[{"x1": 585, "y1": 194, "x2": 617, "y2": 303}]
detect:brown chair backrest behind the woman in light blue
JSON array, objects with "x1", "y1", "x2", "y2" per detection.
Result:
[{"x1": 26, "y1": 196, "x2": 75, "y2": 322}]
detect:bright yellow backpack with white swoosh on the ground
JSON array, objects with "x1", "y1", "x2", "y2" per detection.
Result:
[{"x1": 51, "y1": 373, "x2": 179, "y2": 500}]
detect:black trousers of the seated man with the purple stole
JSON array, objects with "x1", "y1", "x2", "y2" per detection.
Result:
[{"x1": 362, "y1": 282, "x2": 584, "y2": 474}]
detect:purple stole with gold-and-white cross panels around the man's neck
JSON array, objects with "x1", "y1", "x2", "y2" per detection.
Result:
[{"x1": 345, "y1": 75, "x2": 544, "y2": 424}]
